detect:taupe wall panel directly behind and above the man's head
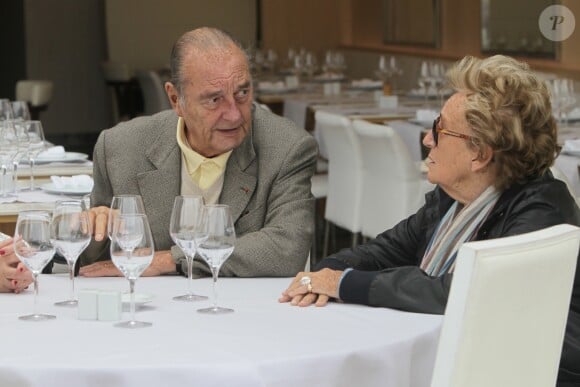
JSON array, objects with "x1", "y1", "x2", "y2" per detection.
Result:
[{"x1": 105, "y1": 0, "x2": 256, "y2": 69}]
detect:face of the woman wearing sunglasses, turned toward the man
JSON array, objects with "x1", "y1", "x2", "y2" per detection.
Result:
[{"x1": 423, "y1": 93, "x2": 481, "y2": 203}]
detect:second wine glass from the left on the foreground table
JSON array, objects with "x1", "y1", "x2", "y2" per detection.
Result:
[{"x1": 51, "y1": 200, "x2": 91, "y2": 306}]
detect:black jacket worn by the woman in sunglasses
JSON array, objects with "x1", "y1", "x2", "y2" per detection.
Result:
[{"x1": 316, "y1": 174, "x2": 580, "y2": 382}]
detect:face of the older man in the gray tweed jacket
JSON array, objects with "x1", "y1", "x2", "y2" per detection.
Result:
[{"x1": 166, "y1": 46, "x2": 253, "y2": 157}]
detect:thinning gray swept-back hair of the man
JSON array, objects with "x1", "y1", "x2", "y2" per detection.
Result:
[{"x1": 170, "y1": 27, "x2": 250, "y2": 99}]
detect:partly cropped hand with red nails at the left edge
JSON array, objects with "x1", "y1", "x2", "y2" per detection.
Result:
[{"x1": 0, "y1": 239, "x2": 32, "y2": 293}]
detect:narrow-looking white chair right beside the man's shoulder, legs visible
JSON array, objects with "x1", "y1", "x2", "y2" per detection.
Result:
[{"x1": 315, "y1": 111, "x2": 362, "y2": 256}]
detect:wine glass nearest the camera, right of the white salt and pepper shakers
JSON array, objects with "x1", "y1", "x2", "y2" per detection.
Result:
[{"x1": 111, "y1": 214, "x2": 154, "y2": 328}]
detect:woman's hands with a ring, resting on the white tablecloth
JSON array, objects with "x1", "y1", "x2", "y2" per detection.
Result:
[{"x1": 278, "y1": 269, "x2": 342, "y2": 306}]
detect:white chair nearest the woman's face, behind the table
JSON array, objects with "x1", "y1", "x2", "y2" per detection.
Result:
[{"x1": 353, "y1": 120, "x2": 434, "y2": 237}]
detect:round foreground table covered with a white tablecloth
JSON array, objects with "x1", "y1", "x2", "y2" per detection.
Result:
[{"x1": 0, "y1": 274, "x2": 442, "y2": 387}]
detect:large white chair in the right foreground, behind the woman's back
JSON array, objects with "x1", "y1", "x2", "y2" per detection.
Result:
[{"x1": 431, "y1": 225, "x2": 580, "y2": 387}]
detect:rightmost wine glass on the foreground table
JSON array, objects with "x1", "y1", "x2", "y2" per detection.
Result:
[{"x1": 197, "y1": 204, "x2": 236, "y2": 314}]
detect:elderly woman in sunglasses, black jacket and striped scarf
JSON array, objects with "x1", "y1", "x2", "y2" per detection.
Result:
[{"x1": 280, "y1": 56, "x2": 580, "y2": 386}]
